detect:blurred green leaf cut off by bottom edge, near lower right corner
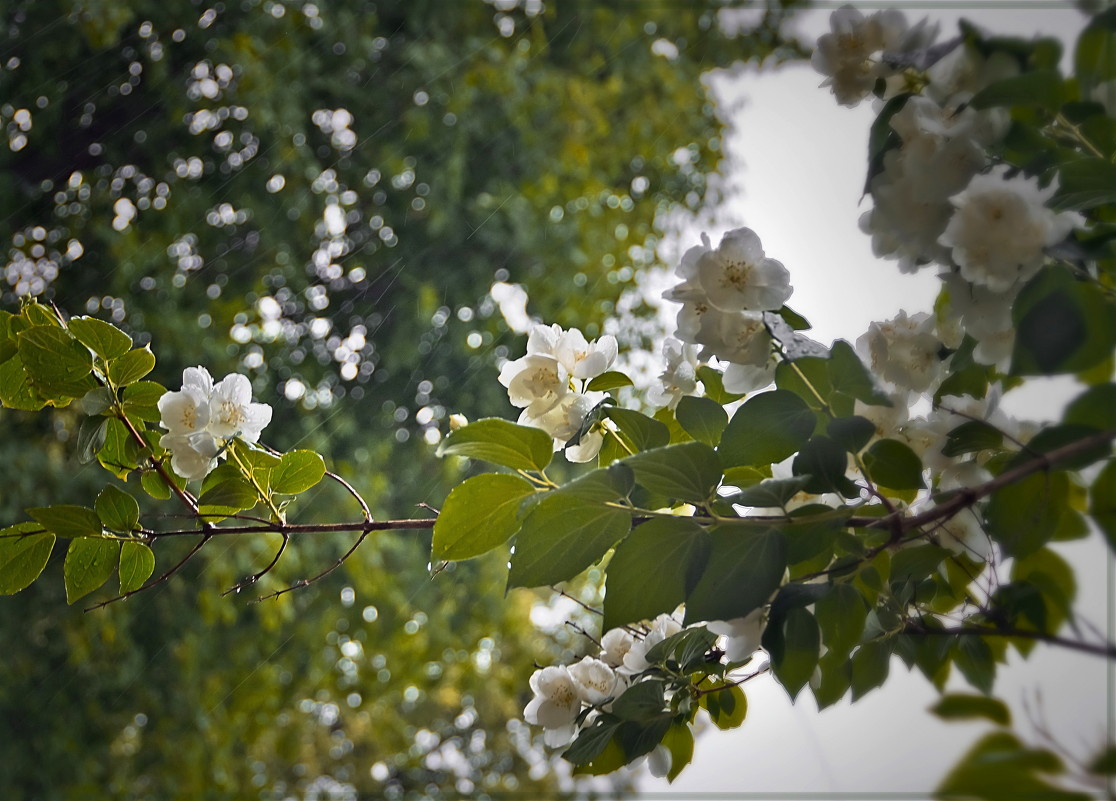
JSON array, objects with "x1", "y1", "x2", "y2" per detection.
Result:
[{"x1": 934, "y1": 731, "x2": 1094, "y2": 801}]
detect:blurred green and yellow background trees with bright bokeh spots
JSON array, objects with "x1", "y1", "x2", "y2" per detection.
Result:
[{"x1": 0, "y1": 0, "x2": 802, "y2": 799}]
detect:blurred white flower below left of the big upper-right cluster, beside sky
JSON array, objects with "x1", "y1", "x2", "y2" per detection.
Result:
[{"x1": 856, "y1": 311, "x2": 943, "y2": 393}]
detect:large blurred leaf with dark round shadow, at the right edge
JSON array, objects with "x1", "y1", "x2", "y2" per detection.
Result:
[{"x1": 1011, "y1": 266, "x2": 1116, "y2": 376}]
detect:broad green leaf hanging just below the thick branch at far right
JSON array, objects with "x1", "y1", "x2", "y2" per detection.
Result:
[{"x1": 984, "y1": 472, "x2": 1069, "y2": 557}]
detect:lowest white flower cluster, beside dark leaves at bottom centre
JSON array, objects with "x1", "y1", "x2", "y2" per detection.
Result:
[{"x1": 523, "y1": 610, "x2": 764, "y2": 775}]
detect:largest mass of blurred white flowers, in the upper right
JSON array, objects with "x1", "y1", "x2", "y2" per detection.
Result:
[{"x1": 812, "y1": 7, "x2": 1083, "y2": 370}]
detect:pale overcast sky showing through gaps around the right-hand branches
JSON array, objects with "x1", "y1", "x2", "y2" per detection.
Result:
[{"x1": 639, "y1": 2, "x2": 1109, "y2": 801}]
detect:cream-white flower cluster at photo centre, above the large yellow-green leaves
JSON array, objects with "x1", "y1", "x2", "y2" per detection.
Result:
[{"x1": 500, "y1": 325, "x2": 616, "y2": 462}]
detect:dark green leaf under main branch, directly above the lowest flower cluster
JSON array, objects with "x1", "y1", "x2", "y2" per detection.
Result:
[{"x1": 686, "y1": 524, "x2": 787, "y2": 624}]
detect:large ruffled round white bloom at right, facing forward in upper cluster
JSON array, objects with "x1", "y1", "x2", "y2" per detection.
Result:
[{"x1": 939, "y1": 165, "x2": 1083, "y2": 292}]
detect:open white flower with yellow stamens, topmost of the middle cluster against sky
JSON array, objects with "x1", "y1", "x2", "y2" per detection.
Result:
[{"x1": 696, "y1": 228, "x2": 791, "y2": 311}]
